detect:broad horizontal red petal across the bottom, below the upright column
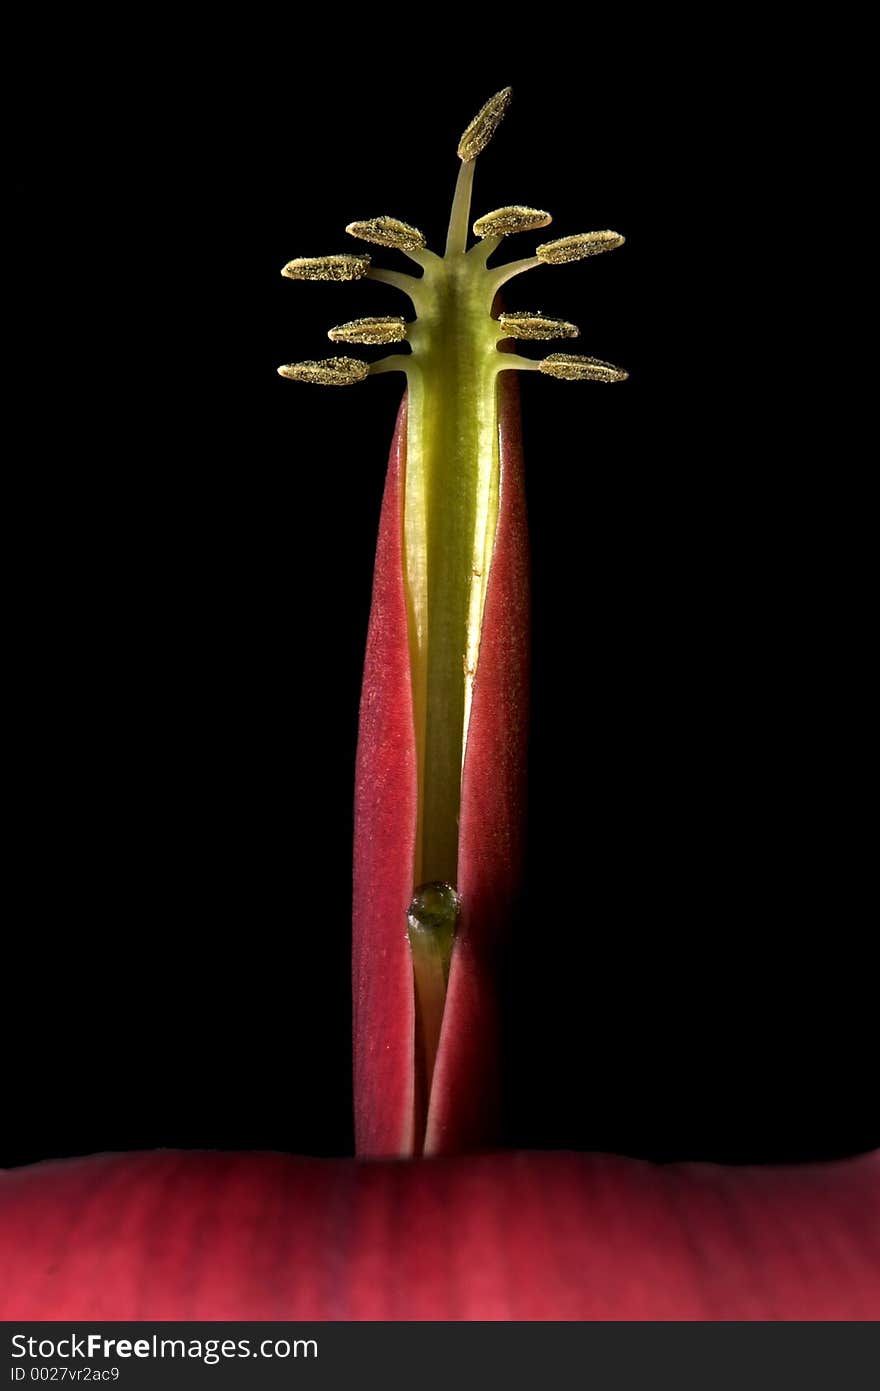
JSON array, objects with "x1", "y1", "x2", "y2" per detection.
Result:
[{"x1": 0, "y1": 1152, "x2": 880, "y2": 1320}]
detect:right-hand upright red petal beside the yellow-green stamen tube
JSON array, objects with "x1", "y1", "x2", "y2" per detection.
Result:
[{"x1": 425, "y1": 371, "x2": 530, "y2": 1155}]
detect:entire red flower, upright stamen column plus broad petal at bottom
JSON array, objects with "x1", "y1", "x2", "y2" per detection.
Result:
[{"x1": 0, "y1": 89, "x2": 880, "y2": 1320}]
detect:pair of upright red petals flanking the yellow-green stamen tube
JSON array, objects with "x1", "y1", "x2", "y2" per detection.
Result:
[{"x1": 353, "y1": 373, "x2": 528, "y2": 1155}]
